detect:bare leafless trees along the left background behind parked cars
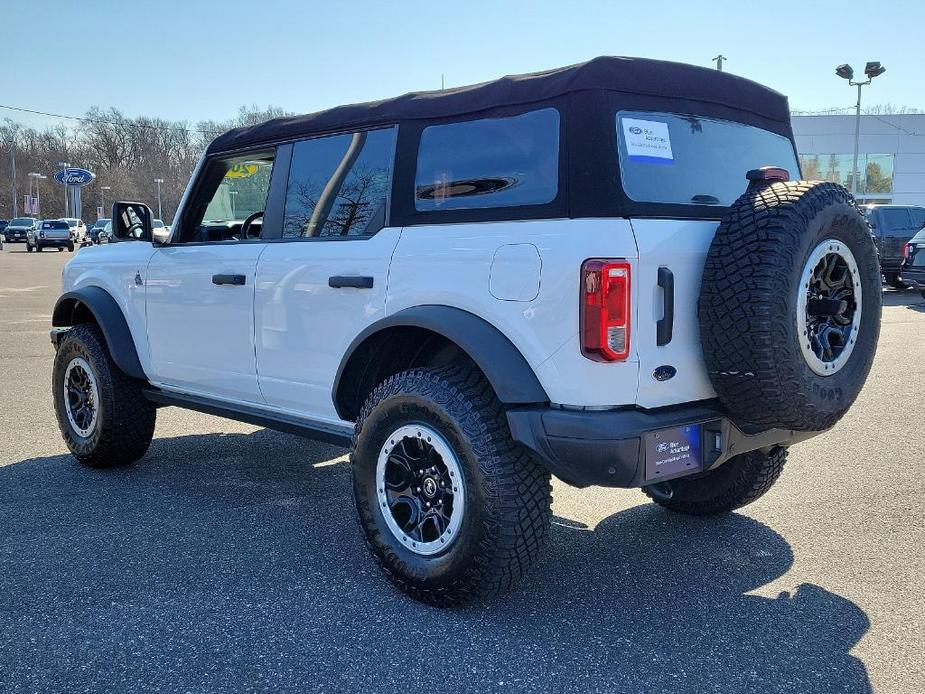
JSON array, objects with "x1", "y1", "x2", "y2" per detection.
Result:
[{"x1": 0, "y1": 106, "x2": 287, "y2": 223}]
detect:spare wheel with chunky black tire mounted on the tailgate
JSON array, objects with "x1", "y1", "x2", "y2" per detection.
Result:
[{"x1": 698, "y1": 181, "x2": 881, "y2": 431}]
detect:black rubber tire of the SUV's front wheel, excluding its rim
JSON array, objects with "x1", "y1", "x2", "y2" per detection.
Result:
[{"x1": 52, "y1": 323, "x2": 157, "y2": 468}]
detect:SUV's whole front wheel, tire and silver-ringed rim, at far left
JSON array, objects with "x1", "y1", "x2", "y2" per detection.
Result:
[{"x1": 52, "y1": 323, "x2": 157, "y2": 468}]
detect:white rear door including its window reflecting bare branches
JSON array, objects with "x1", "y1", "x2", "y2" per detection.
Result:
[{"x1": 255, "y1": 123, "x2": 401, "y2": 422}]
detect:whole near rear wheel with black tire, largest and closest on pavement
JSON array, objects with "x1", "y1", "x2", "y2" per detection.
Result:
[{"x1": 351, "y1": 364, "x2": 552, "y2": 607}]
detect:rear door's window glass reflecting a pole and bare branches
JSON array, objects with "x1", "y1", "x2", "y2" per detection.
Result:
[{"x1": 283, "y1": 128, "x2": 395, "y2": 238}]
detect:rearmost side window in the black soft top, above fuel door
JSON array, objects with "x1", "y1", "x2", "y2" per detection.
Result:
[{"x1": 414, "y1": 108, "x2": 559, "y2": 212}]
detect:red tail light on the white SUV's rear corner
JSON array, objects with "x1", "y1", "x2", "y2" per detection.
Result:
[{"x1": 581, "y1": 259, "x2": 630, "y2": 361}]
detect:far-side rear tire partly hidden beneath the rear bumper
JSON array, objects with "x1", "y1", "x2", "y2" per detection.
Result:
[{"x1": 643, "y1": 448, "x2": 787, "y2": 516}]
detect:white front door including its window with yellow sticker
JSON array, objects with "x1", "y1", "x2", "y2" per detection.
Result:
[{"x1": 143, "y1": 151, "x2": 275, "y2": 404}]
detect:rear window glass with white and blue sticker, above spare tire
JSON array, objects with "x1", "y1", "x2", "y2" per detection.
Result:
[{"x1": 616, "y1": 111, "x2": 800, "y2": 206}]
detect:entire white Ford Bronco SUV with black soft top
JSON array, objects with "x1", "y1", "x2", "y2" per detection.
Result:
[{"x1": 52, "y1": 58, "x2": 881, "y2": 605}]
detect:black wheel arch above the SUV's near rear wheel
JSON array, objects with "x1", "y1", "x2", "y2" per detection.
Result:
[{"x1": 332, "y1": 305, "x2": 549, "y2": 421}]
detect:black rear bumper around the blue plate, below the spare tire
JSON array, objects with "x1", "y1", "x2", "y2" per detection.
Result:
[{"x1": 507, "y1": 401, "x2": 820, "y2": 487}]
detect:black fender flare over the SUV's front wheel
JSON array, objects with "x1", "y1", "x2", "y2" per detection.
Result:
[{"x1": 51, "y1": 286, "x2": 148, "y2": 380}]
